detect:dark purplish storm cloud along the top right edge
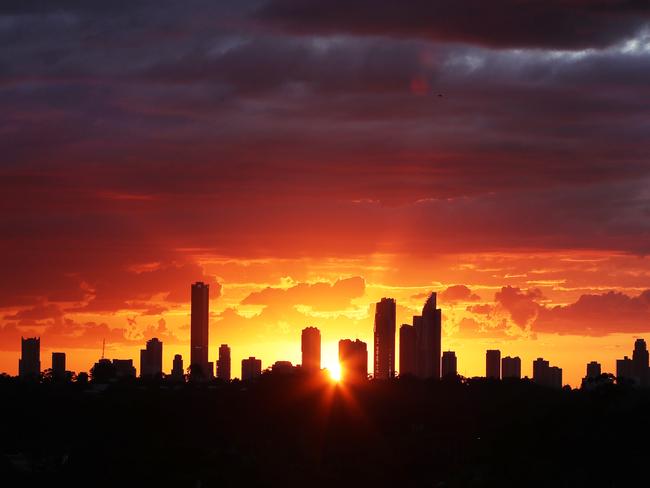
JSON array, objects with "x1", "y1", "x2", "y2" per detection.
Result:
[{"x1": 256, "y1": 0, "x2": 650, "y2": 49}]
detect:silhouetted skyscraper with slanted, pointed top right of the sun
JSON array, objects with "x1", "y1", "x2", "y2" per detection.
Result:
[{"x1": 413, "y1": 293, "x2": 442, "y2": 379}]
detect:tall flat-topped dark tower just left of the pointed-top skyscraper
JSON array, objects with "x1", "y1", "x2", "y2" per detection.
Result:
[{"x1": 374, "y1": 298, "x2": 396, "y2": 380}]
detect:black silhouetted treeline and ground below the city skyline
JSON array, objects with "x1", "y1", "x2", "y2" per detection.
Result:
[{"x1": 0, "y1": 374, "x2": 650, "y2": 487}]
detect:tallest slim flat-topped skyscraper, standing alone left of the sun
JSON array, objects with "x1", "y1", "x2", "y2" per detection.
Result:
[{"x1": 190, "y1": 281, "x2": 210, "y2": 378}]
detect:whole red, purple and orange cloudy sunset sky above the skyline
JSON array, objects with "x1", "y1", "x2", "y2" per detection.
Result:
[{"x1": 0, "y1": 0, "x2": 650, "y2": 386}]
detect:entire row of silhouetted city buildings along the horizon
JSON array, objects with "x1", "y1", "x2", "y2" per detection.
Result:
[{"x1": 12, "y1": 282, "x2": 650, "y2": 388}]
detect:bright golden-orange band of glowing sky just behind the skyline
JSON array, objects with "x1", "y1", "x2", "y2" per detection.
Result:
[{"x1": 0, "y1": 253, "x2": 648, "y2": 386}]
